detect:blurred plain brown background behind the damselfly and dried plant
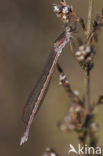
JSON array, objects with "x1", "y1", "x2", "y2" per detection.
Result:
[{"x1": 0, "y1": 0, "x2": 103, "y2": 156}]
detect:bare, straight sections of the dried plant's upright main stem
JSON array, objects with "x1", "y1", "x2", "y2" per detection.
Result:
[{"x1": 85, "y1": 0, "x2": 94, "y2": 113}]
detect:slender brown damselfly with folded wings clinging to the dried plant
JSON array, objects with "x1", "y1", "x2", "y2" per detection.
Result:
[{"x1": 20, "y1": 26, "x2": 73, "y2": 145}]
